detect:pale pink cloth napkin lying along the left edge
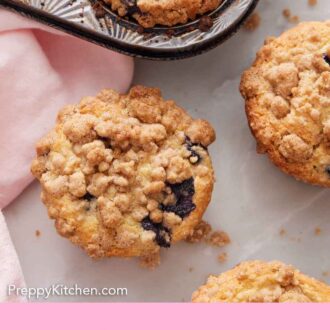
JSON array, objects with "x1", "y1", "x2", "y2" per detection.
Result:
[{"x1": 0, "y1": 10, "x2": 134, "y2": 301}]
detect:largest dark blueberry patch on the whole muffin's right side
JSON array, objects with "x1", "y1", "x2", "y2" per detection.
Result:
[{"x1": 161, "y1": 178, "x2": 196, "y2": 219}]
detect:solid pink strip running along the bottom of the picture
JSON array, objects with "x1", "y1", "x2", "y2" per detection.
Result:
[{"x1": 0, "y1": 303, "x2": 330, "y2": 330}]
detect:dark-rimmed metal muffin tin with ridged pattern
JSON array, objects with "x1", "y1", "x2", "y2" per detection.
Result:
[{"x1": 0, "y1": 0, "x2": 259, "y2": 60}]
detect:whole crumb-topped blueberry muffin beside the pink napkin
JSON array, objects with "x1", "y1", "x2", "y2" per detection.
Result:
[{"x1": 32, "y1": 86, "x2": 215, "y2": 258}]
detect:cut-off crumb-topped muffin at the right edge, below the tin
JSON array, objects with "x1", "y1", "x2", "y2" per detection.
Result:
[{"x1": 241, "y1": 22, "x2": 330, "y2": 187}]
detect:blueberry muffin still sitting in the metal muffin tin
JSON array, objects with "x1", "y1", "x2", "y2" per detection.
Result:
[{"x1": 104, "y1": 0, "x2": 222, "y2": 28}]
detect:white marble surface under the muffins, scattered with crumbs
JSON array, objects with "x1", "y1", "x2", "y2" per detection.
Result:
[{"x1": 5, "y1": 0, "x2": 330, "y2": 302}]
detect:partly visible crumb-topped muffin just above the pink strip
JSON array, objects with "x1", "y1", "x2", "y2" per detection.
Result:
[{"x1": 192, "y1": 261, "x2": 330, "y2": 303}]
